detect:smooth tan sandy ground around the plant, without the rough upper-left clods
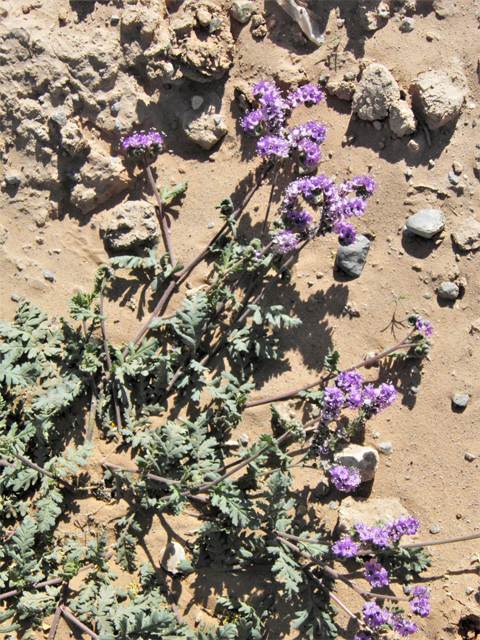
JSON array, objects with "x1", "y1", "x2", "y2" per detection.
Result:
[{"x1": 0, "y1": 0, "x2": 480, "y2": 640}]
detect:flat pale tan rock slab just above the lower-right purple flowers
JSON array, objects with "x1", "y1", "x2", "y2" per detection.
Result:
[{"x1": 337, "y1": 498, "x2": 410, "y2": 533}]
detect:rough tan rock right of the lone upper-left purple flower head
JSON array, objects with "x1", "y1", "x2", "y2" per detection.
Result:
[{"x1": 182, "y1": 91, "x2": 228, "y2": 149}]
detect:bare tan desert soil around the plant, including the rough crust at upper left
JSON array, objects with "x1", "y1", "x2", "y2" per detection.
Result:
[{"x1": 0, "y1": 0, "x2": 480, "y2": 640}]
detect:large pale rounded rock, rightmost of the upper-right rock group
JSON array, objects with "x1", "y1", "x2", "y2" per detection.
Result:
[{"x1": 410, "y1": 70, "x2": 468, "y2": 131}]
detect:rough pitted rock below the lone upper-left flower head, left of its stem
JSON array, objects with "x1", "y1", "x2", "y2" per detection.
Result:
[{"x1": 101, "y1": 201, "x2": 160, "y2": 251}]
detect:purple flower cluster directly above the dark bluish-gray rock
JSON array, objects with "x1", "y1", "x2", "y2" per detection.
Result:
[{"x1": 283, "y1": 172, "x2": 374, "y2": 244}]
